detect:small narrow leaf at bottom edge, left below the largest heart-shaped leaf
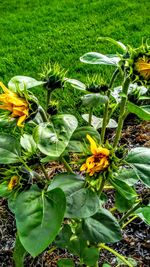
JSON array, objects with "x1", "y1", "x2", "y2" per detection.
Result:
[{"x1": 13, "y1": 235, "x2": 27, "y2": 267}]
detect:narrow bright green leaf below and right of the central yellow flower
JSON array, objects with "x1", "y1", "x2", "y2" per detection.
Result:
[{"x1": 110, "y1": 178, "x2": 137, "y2": 200}]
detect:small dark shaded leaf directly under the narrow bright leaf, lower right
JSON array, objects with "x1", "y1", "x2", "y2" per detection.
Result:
[{"x1": 115, "y1": 191, "x2": 135, "y2": 212}]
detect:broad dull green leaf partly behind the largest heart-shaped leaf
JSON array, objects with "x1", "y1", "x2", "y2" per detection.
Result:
[{"x1": 48, "y1": 173, "x2": 100, "y2": 218}]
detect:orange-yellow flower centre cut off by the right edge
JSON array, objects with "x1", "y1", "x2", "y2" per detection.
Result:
[{"x1": 135, "y1": 57, "x2": 150, "y2": 81}]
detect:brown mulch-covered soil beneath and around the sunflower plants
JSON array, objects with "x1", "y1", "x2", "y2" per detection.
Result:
[{"x1": 0, "y1": 122, "x2": 150, "y2": 267}]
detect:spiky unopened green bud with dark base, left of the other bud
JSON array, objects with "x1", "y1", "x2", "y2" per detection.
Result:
[{"x1": 41, "y1": 63, "x2": 67, "y2": 91}]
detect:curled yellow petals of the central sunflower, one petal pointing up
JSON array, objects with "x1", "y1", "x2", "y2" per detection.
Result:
[{"x1": 80, "y1": 135, "x2": 110, "y2": 176}]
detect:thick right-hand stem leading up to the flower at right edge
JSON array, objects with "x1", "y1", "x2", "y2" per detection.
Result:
[{"x1": 113, "y1": 77, "x2": 130, "y2": 149}]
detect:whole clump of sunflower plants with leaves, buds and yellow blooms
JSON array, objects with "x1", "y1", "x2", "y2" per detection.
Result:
[{"x1": 0, "y1": 38, "x2": 150, "y2": 267}]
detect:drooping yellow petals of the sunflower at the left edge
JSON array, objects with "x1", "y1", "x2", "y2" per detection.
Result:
[{"x1": 0, "y1": 82, "x2": 29, "y2": 127}]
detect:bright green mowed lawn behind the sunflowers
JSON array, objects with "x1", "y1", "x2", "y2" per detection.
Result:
[{"x1": 0, "y1": 0, "x2": 150, "y2": 117}]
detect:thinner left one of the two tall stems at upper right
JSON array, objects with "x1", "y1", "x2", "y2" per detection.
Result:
[{"x1": 101, "y1": 69, "x2": 119, "y2": 143}]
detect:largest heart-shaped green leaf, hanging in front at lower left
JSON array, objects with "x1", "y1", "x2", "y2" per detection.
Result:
[{"x1": 15, "y1": 186, "x2": 66, "y2": 257}]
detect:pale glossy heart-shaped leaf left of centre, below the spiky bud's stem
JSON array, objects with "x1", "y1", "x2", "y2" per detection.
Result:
[{"x1": 33, "y1": 114, "x2": 78, "y2": 158}]
